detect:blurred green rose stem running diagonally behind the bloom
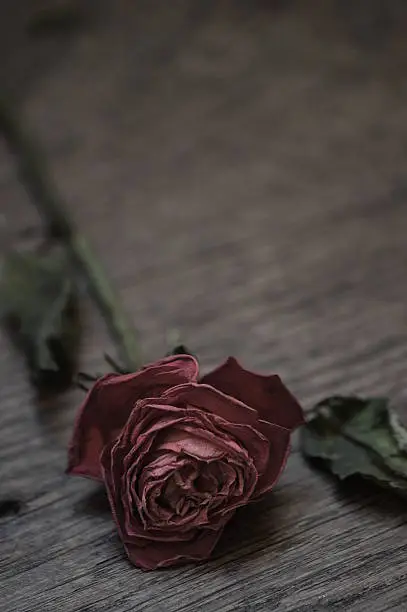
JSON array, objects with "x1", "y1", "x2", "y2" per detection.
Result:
[{"x1": 0, "y1": 100, "x2": 142, "y2": 371}]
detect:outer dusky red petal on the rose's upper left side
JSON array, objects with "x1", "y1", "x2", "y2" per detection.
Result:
[{"x1": 67, "y1": 355, "x2": 198, "y2": 480}]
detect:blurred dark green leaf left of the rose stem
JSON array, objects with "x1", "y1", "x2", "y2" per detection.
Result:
[{"x1": 0, "y1": 253, "x2": 80, "y2": 386}]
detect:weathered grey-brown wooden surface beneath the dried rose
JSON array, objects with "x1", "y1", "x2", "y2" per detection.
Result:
[{"x1": 0, "y1": 0, "x2": 407, "y2": 612}]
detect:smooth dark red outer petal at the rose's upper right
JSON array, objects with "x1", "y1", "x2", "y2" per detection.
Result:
[{"x1": 201, "y1": 357, "x2": 304, "y2": 430}]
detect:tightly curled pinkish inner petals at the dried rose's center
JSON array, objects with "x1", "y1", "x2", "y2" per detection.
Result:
[{"x1": 133, "y1": 421, "x2": 257, "y2": 529}]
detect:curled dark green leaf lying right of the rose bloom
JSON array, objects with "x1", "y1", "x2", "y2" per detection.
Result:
[{"x1": 301, "y1": 396, "x2": 407, "y2": 496}]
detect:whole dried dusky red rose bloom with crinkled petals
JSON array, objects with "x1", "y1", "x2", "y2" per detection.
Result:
[{"x1": 68, "y1": 355, "x2": 303, "y2": 570}]
